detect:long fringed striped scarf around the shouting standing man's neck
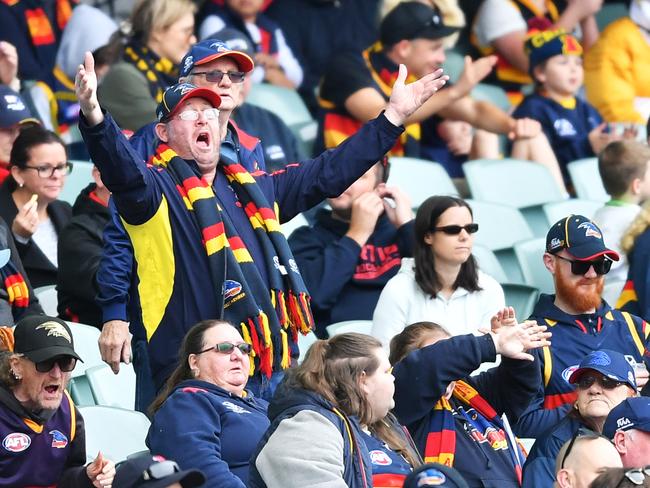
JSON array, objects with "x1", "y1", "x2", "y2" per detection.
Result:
[{"x1": 152, "y1": 144, "x2": 314, "y2": 377}]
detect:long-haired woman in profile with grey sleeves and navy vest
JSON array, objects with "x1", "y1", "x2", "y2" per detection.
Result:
[{"x1": 249, "y1": 333, "x2": 421, "y2": 488}]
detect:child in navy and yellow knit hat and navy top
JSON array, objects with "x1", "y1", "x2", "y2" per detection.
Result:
[{"x1": 514, "y1": 29, "x2": 614, "y2": 186}]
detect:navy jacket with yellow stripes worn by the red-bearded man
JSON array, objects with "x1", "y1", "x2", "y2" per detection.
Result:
[{"x1": 516, "y1": 295, "x2": 650, "y2": 438}]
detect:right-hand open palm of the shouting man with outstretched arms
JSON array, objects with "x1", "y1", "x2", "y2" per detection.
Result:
[{"x1": 384, "y1": 64, "x2": 449, "y2": 125}]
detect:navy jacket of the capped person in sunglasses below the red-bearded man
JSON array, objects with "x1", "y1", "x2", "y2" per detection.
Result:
[{"x1": 522, "y1": 417, "x2": 586, "y2": 488}]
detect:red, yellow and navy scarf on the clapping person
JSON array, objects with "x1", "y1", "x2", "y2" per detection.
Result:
[{"x1": 424, "y1": 380, "x2": 526, "y2": 485}]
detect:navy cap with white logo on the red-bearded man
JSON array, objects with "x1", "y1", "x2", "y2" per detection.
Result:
[{"x1": 546, "y1": 215, "x2": 619, "y2": 261}]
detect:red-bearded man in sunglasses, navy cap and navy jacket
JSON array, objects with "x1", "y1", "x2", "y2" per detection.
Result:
[{"x1": 516, "y1": 215, "x2": 650, "y2": 437}]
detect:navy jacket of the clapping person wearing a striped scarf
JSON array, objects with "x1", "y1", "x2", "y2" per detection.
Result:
[{"x1": 393, "y1": 334, "x2": 541, "y2": 488}]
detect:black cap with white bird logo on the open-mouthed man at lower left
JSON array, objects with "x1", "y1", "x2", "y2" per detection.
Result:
[{"x1": 14, "y1": 315, "x2": 81, "y2": 363}]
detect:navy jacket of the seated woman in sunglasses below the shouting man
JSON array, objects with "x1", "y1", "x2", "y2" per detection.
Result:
[{"x1": 147, "y1": 380, "x2": 269, "y2": 488}]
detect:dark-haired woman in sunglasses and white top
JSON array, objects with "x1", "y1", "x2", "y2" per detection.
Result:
[{"x1": 372, "y1": 196, "x2": 505, "y2": 350}]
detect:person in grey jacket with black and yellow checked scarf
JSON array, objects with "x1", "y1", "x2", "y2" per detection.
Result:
[{"x1": 97, "y1": 0, "x2": 196, "y2": 131}]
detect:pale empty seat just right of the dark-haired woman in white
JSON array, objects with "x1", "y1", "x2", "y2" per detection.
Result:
[{"x1": 468, "y1": 200, "x2": 533, "y2": 283}]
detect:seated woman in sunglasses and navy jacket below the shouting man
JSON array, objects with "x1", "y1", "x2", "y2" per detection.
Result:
[{"x1": 147, "y1": 320, "x2": 269, "y2": 488}]
